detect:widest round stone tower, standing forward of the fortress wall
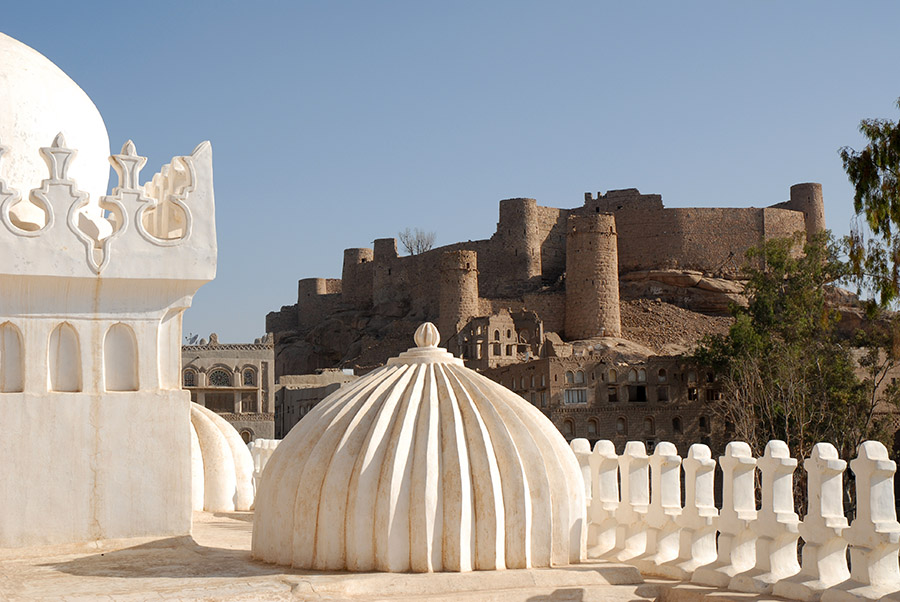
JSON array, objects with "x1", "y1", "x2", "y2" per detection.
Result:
[{"x1": 565, "y1": 213, "x2": 622, "y2": 341}]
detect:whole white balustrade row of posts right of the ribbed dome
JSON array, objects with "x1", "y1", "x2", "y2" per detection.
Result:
[{"x1": 572, "y1": 441, "x2": 900, "y2": 602}]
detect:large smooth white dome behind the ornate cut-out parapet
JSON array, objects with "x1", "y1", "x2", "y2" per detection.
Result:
[{"x1": 0, "y1": 33, "x2": 109, "y2": 202}]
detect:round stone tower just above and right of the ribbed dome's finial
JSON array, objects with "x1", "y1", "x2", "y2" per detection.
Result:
[{"x1": 438, "y1": 250, "x2": 478, "y2": 340}]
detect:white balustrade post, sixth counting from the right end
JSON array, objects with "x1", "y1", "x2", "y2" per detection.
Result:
[{"x1": 631, "y1": 441, "x2": 681, "y2": 575}]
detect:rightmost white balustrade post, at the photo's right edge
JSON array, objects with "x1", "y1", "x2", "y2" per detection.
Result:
[{"x1": 822, "y1": 441, "x2": 900, "y2": 602}]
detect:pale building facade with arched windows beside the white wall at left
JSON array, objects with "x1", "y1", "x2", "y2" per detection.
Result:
[{"x1": 181, "y1": 333, "x2": 275, "y2": 443}]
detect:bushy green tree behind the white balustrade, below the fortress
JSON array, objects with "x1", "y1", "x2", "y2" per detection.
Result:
[{"x1": 693, "y1": 233, "x2": 898, "y2": 466}]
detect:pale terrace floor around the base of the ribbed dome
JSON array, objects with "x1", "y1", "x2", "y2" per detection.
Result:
[{"x1": 0, "y1": 513, "x2": 796, "y2": 602}]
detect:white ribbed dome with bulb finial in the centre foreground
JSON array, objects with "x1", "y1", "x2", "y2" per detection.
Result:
[{"x1": 252, "y1": 324, "x2": 586, "y2": 572}]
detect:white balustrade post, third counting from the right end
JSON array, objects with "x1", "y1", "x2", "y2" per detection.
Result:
[{"x1": 728, "y1": 440, "x2": 800, "y2": 593}]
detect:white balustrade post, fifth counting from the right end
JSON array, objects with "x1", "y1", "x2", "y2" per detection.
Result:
[{"x1": 657, "y1": 443, "x2": 719, "y2": 579}]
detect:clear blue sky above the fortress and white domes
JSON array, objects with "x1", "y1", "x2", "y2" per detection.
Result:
[{"x1": 0, "y1": 0, "x2": 900, "y2": 342}]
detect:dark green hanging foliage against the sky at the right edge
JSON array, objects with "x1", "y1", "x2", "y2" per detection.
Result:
[{"x1": 840, "y1": 99, "x2": 900, "y2": 306}]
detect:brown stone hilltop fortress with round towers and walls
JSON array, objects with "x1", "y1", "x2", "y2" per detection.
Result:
[{"x1": 266, "y1": 183, "x2": 825, "y2": 375}]
